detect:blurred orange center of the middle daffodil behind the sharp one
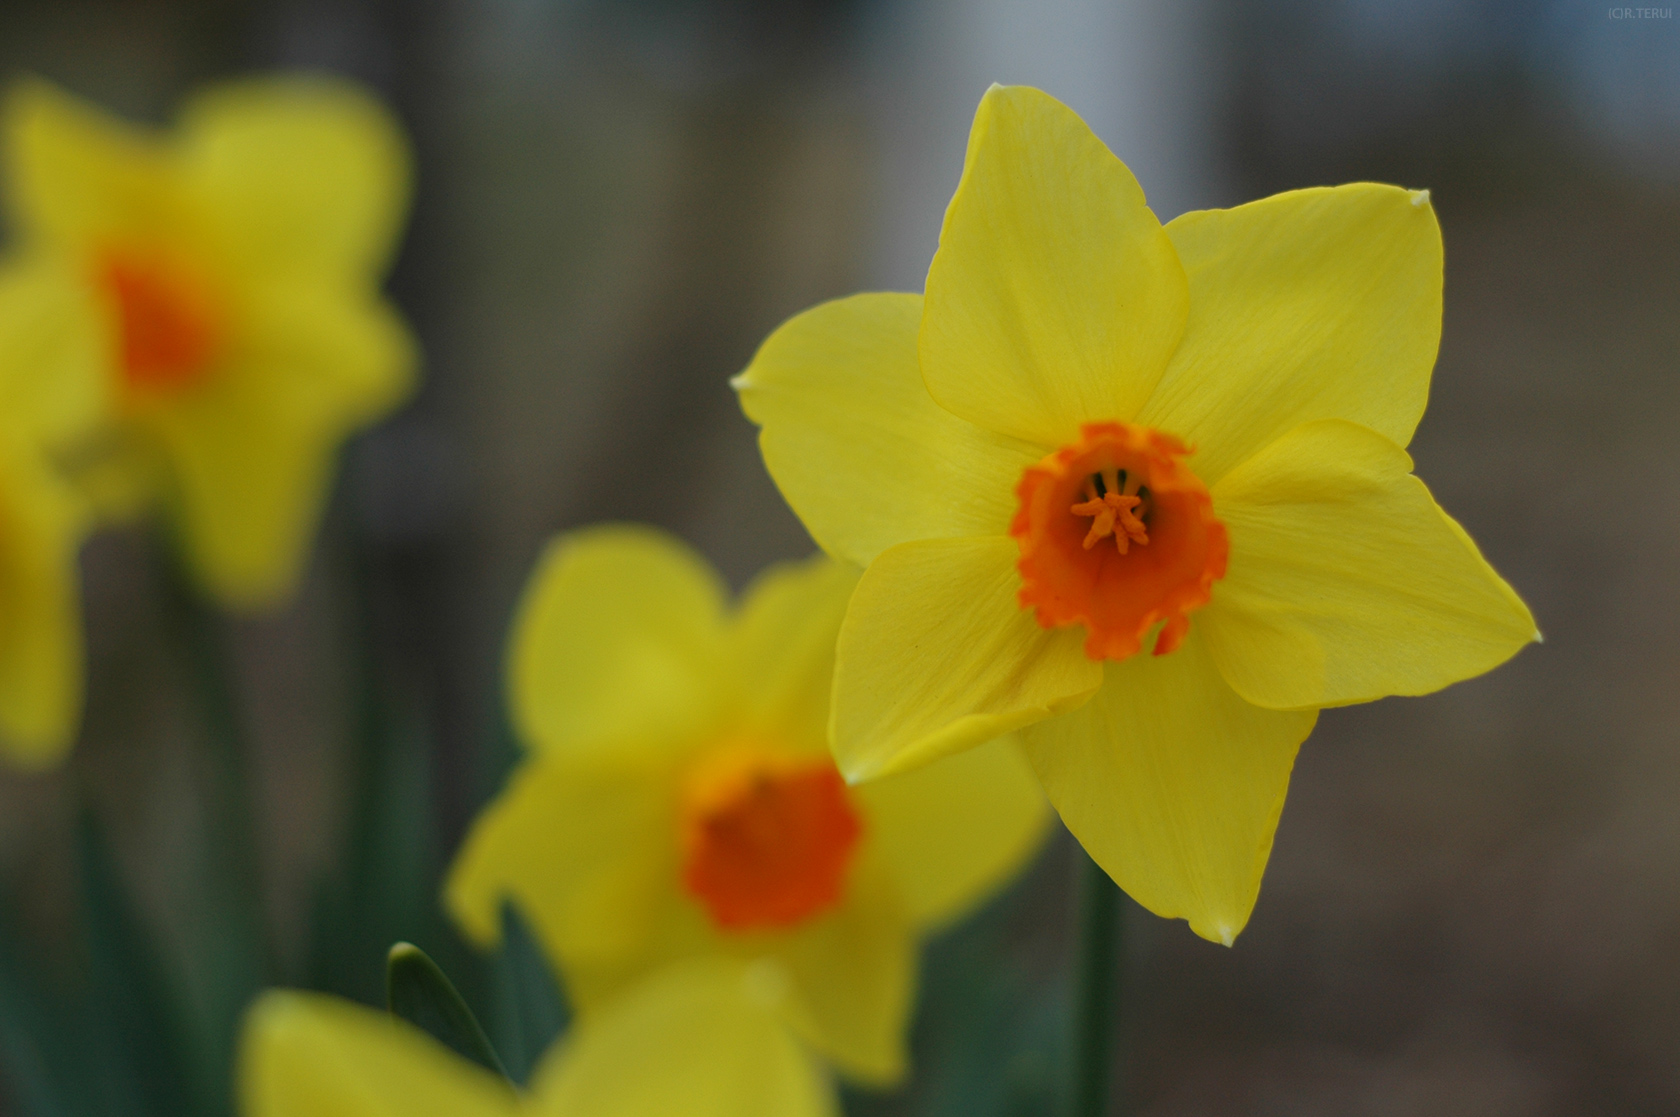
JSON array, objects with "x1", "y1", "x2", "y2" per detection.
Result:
[{"x1": 680, "y1": 749, "x2": 864, "y2": 931}]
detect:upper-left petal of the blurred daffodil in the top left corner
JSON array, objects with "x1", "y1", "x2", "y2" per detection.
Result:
[{"x1": 3, "y1": 81, "x2": 187, "y2": 252}]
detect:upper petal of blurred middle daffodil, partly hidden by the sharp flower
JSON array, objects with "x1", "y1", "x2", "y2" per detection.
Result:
[{"x1": 729, "y1": 558, "x2": 858, "y2": 753}]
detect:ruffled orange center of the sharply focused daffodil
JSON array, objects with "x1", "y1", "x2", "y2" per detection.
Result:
[{"x1": 1010, "y1": 423, "x2": 1230, "y2": 660}]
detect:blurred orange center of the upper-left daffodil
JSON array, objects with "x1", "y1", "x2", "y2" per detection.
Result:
[{"x1": 97, "y1": 250, "x2": 222, "y2": 393}]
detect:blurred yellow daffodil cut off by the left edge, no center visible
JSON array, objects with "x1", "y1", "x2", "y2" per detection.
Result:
[{"x1": 0, "y1": 269, "x2": 104, "y2": 768}]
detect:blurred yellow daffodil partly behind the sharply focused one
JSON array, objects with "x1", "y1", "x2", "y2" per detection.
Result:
[{"x1": 445, "y1": 527, "x2": 1048, "y2": 1083}]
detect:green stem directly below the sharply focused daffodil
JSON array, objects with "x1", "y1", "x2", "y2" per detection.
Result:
[{"x1": 1072, "y1": 855, "x2": 1121, "y2": 1117}]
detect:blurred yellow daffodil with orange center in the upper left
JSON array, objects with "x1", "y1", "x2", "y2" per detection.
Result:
[{"x1": 0, "y1": 77, "x2": 415, "y2": 608}]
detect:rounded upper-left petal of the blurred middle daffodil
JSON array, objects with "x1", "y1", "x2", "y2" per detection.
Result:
[{"x1": 509, "y1": 526, "x2": 729, "y2": 756}]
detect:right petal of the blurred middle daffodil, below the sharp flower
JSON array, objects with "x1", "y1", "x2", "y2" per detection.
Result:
[{"x1": 853, "y1": 736, "x2": 1050, "y2": 931}]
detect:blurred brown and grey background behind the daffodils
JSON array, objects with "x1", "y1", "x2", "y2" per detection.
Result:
[{"x1": 0, "y1": 0, "x2": 1680, "y2": 1117}]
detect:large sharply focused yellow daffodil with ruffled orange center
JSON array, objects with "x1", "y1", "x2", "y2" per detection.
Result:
[{"x1": 736, "y1": 86, "x2": 1539, "y2": 944}]
